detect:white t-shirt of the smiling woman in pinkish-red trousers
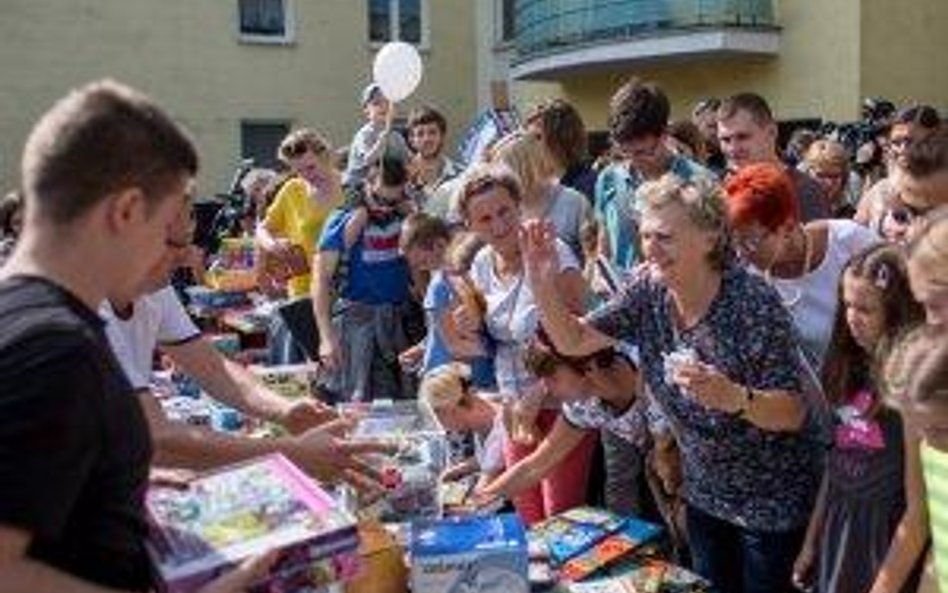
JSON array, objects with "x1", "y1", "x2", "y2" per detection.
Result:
[{"x1": 470, "y1": 239, "x2": 579, "y2": 394}]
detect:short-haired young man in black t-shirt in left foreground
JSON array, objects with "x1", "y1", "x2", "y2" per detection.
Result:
[{"x1": 0, "y1": 81, "x2": 262, "y2": 593}]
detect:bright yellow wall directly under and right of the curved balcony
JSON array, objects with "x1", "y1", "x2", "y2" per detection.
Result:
[{"x1": 517, "y1": 0, "x2": 872, "y2": 129}]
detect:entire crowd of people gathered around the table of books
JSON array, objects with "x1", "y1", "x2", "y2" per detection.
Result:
[{"x1": 0, "y1": 74, "x2": 948, "y2": 593}]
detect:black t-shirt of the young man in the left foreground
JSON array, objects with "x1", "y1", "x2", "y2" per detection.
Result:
[{"x1": 0, "y1": 277, "x2": 151, "y2": 590}]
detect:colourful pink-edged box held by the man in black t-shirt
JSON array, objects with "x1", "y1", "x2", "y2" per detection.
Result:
[{"x1": 146, "y1": 455, "x2": 358, "y2": 593}]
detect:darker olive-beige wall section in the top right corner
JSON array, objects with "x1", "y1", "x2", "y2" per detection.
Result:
[{"x1": 861, "y1": 0, "x2": 948, "y2": 108}]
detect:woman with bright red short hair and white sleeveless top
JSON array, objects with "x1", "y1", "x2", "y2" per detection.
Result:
[{"x1": 724, "y1": 163, "x2": 880, "y2": 369}]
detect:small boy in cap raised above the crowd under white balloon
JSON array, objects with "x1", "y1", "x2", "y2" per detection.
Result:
[{"x1": 342, "y1": 82, "x2": 411, "y2": 186}]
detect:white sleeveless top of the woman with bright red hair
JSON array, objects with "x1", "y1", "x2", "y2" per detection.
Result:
[{"x1": 773, "y1": 219, "x2": 881, "y2": 370}]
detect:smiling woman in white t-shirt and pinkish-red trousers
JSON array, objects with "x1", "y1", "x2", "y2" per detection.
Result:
[{"x1": 457, "y1": 165, "x2": 595, "y2": 524}]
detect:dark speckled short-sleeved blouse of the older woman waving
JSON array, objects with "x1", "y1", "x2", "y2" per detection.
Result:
[{"x1": 587, "y1": 266, "x2": 820, "y2": 531}]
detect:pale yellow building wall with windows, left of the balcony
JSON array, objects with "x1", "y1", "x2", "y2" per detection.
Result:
[{"x1": 0, "y1": 0, "x2": 475, "y2": 199}]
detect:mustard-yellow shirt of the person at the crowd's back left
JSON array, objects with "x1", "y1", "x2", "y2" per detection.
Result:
[{"x1": 263, "y1": 177, "x2": 342, "y2": 298}]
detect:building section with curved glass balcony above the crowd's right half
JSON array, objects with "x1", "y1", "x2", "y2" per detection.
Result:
[{"x1": 479, "y1": 0, "x2": 948, "y2": 138}]
